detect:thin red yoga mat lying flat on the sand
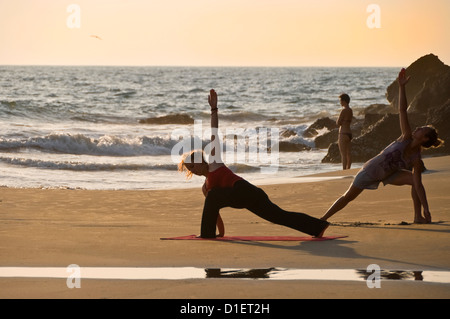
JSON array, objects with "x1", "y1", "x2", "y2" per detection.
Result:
[{"x1": 161, "y1": 235, "x2": 348, "y2": 241}]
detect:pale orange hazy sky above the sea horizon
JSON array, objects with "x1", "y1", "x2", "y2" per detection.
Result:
[{"x1": 0, "y1": 0, "x2": 450, "y2": 67}]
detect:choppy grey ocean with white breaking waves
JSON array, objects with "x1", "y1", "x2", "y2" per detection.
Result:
[{"x1": 0, "y1": 66, "x2": 398, "y2": 190}]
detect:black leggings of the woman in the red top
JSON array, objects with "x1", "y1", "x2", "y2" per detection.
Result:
[{"x1": 200, "y1": 180, "x2": 329, "y2": 238}]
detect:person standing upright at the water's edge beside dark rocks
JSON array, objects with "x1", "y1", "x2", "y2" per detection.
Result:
[{"x1": 336, "y1": 94, "x2": 353, "y2": 170}]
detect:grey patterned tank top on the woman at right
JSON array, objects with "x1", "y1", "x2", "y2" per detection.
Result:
[{"x1": 363, "y1": 139, "x2": 420, "y2": 181}]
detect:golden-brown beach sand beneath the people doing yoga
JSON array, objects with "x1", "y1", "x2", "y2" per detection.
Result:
[{"x1": 0, "y1": 156, "x2": 450, "y2": 299}]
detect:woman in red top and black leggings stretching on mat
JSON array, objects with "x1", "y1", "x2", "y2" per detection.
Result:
[{"x1": 178, "y1": 90, "x2": 329, "y2": 238}]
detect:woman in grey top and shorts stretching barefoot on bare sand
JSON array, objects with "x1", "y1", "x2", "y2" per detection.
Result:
[{"x1": 321, "y1": 69, "x2": 442, "y2": 223}]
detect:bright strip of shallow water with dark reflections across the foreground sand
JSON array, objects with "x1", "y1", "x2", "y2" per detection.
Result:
[{"x1": 0, "y1": 267, "x2": 450, "y2": 284}]
